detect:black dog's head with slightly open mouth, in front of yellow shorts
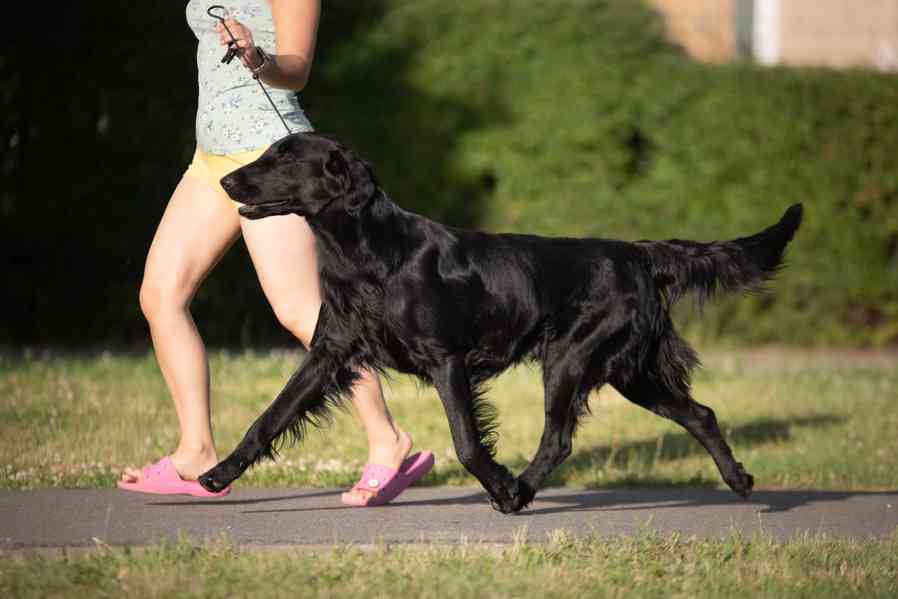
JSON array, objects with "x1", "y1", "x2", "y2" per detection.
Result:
[{"x1": 221, "y1": 133, "x2": 378, "y2": 219}]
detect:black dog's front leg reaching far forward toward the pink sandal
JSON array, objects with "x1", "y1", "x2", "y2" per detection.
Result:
[{"x1": 199, "y1": 345, "x2": 356, "y2": 491}]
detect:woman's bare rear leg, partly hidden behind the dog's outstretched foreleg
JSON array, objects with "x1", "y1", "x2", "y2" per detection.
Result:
[{"x1": 240, "y1": 214, "x2": 412, "y2": 500}]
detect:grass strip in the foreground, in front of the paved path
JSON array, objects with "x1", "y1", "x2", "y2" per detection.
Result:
[{"x1": 0, "y1": 532, "x2": 898, "y2": 599}]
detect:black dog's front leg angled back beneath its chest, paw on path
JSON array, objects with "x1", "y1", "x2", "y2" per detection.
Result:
[{"x1": 432, "y1": 356, "x2": 520, "y2": 514}]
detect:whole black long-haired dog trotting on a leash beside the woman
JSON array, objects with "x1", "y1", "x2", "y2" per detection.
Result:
[{"x1": 200, "y1": 133, "x2": 802, "y2": 513}]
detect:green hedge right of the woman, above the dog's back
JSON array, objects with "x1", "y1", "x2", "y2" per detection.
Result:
[{"x1": 304, "y1": 0, "x2": 898, "y2": 344}]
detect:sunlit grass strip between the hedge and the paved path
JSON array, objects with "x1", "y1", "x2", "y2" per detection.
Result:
[{"x1": 0, "y1": 351, "x2": 898, "y2": 490}]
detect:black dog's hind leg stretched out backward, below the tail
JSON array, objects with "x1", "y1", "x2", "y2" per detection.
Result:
[{"x1": 613, "y1": 333, "x2": 754, "y2": 499}]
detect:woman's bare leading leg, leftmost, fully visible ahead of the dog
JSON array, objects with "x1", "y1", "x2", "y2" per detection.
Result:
[{"x1": 122, "y1": 176, "x2": 240, "y2": 481}]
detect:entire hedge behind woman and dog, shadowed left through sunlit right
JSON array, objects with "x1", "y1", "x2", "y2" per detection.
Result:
[{"x1": 0, "y1": 0, "x2": 898, "y2": 345}]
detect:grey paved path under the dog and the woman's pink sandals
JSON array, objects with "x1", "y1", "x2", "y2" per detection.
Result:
[{"x1": 0, "y1": 487, "x2": 898, "y2": 551}]
